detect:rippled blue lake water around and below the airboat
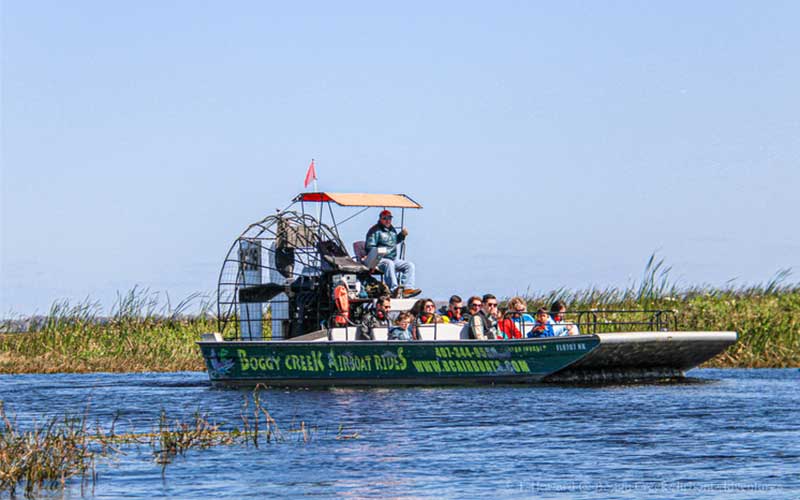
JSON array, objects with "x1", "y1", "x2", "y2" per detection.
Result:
[{"x1": 0, "y1": 369, "x2": 800, "y2": 498}]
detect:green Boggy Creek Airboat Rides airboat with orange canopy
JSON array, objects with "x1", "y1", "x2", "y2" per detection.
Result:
[{"x1": 198, "y1": 192, "x2": 737, "y2": 387}]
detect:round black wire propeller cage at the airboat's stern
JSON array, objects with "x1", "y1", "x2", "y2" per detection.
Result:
[{"x1": 217, "y1": 211, "x2": 340, "y2": 340}]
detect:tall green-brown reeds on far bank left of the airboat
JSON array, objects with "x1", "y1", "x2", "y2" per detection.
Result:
[{"x1": 0, "y1": 288, "x2": 212, "y2": 373}]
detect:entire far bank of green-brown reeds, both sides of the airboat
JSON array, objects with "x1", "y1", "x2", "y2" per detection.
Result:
[{"x1": 0, "y1": 255, "x2": 800, "y2": 373}]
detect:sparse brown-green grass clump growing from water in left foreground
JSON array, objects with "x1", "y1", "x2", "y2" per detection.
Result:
[{"x1": 0, "y1": 387, "x2": 340, "y2": 497}]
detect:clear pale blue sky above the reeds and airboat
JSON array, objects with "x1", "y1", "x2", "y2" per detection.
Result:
[{"x1": 0, "y1": 0, "x2": 800, "y2": 316}]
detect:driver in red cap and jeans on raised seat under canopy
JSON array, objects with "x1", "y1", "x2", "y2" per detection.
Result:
[{"x1": 364, "y1": 210, "x2": 422, "y2": 298}]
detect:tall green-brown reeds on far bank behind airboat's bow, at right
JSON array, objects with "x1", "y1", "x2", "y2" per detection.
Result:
[{"x1": 526, "y1": 254, "x2": 800, "y2": 368}]
